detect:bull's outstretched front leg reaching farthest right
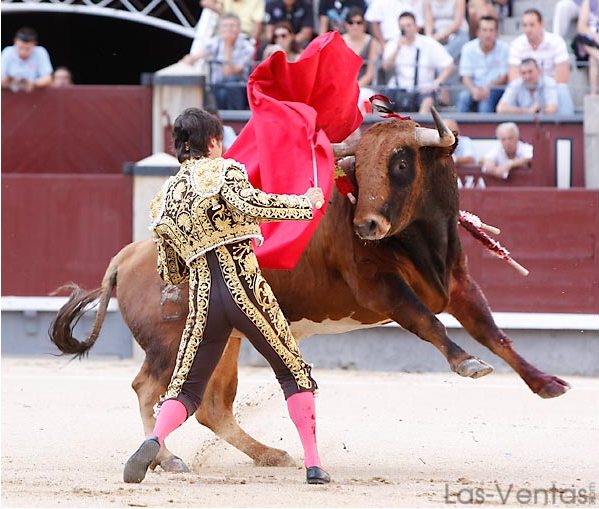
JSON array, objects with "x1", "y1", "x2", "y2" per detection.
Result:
[{"x1": 447, "y1": 258, "x2": 570, "y2": 398}]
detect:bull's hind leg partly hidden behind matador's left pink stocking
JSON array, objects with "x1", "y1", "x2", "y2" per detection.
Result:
[{"x1": 131, "y1": 358, "x2": 189, "y2": 472}]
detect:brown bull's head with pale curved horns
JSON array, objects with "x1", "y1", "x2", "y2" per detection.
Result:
[{"x1": 333, "y1": 108, "x2": 455, "y2": 240}]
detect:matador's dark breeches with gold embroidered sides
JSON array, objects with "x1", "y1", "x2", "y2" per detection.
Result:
[{"x1": 161, "y1": 241, "x2": 316, "y2": 415}]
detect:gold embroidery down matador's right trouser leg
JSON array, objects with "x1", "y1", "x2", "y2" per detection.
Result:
[{"x1": 215, "y1": 242, "x2": 315, "y2": 390}]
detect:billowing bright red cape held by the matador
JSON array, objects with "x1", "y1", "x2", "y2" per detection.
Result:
[{"x1": 225, "y1": 32, "x2": 362, "y2": 269}]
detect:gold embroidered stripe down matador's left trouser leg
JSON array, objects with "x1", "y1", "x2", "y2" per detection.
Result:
[{"x1": 160, "y1": 256, "x2": 211, "y2": 401}]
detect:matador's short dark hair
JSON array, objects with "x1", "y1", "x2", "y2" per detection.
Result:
[{"x1": 173, "y1": 108, "x2": 223, "y2": 163}]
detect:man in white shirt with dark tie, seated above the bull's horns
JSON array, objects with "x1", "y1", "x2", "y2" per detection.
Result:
[{"x1": 383, "y1": 12, "x2": 454, "y2": 113}]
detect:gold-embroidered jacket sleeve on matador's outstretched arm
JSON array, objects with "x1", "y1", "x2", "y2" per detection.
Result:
[{"x1": 221, "y1": 165, "x2": 313, "y2": 222}]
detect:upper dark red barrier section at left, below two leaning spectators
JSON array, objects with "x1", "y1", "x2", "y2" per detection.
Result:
[{"x1": 2, "y1": 85, "x2": 152, "y2": 174}]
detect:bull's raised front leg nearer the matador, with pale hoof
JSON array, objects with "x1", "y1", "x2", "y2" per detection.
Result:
[{"x1": 354, "y1": 274, "x2": 493, "y2": 378}]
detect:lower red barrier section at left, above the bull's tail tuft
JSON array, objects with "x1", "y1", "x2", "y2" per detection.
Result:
[{"x1": 2, "y1": 174, "x2": 133, "y2": 295}]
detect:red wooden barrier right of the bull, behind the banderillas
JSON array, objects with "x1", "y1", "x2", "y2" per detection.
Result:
[{"x1": 460, "y1": 188, "x2": 599, "y2": 313}]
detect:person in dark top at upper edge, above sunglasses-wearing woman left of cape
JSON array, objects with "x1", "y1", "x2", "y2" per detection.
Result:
[{"x1": 264, "y1": 0, "x2": 314, "y2": 47}]
